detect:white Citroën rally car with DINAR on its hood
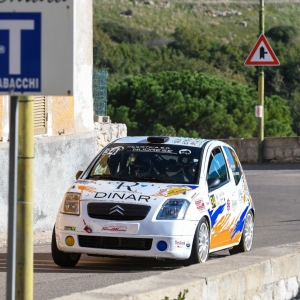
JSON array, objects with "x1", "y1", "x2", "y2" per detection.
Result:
[{"x1": 52, "y1": 136, "x2": 255, "y2": 267}]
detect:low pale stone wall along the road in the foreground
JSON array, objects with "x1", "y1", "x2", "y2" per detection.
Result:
[{"x1": 52, "y1": 242, "x2": 300, "y2": 300}]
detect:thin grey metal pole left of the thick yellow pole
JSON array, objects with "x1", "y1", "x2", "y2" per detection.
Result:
[{"x1": 6, "y1": 96, "x2": 19, "y2": 300}]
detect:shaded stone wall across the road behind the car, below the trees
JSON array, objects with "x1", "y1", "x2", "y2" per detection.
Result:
[{"x1": 222, "y1": 136, "x2": 300, "y2": 163}]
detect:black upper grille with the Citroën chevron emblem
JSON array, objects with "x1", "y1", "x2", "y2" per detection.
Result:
[{"x1": 87, "y1": 202, "x2": 151, "y2": 221}]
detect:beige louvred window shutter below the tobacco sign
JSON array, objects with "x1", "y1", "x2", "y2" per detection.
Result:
[{"x1": 33, "y1": 96, "x2": 47, "y2": 134}]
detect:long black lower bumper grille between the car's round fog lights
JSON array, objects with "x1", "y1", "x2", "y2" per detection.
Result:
[{"x1": 78, "y1": 235, "x2": 152, "y2": 250}]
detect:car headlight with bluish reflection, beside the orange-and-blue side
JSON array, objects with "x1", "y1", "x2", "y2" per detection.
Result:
[{"x1": 156, "y1": 199, "x2": 190, "y2": 220}]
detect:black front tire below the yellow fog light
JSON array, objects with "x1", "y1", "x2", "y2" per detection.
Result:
[{"x1": 51, "y1": 226, "x2": 81, "y2": 268}]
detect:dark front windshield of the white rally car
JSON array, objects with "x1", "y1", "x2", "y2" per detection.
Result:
[{"x1": 87, "y1": 143, "x2": 201, "y2": 184}]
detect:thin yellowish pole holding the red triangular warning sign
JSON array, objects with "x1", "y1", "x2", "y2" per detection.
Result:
[{"x1": 257, "y1": 0, "x2": 265, "y2": 163}]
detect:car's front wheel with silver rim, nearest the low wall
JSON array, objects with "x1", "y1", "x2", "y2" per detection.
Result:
[{"x1": 184, "y1": 217, "x2": 210, "y2": 266}]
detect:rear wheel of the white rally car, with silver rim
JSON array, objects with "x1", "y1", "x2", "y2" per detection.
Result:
[{"x1": 229, "y1": 211, "x2": 254, "y2": 255}]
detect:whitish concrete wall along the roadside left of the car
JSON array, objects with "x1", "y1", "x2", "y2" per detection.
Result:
[{"x1": 0, "y1": 123, "x2": 127, "y2": 233}]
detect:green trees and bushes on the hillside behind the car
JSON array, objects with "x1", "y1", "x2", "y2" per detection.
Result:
[{"x1": 94, "y1": 18, "x2": 300, "y2": 138}]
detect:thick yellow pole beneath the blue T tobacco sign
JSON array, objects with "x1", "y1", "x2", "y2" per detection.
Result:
[{"x1": 15, "y1": 96, "x2": 34, "y2": 300}]
